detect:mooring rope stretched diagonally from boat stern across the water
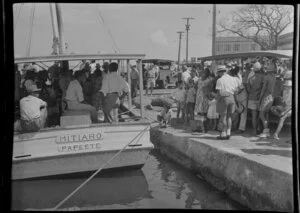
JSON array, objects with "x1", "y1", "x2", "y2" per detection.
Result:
[{"x1": 51, "y1": 125, "x2": 150, "y2": 210}]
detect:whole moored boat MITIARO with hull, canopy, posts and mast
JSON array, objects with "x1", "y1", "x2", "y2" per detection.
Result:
[{"x1": 12, "y1": 3, "x2": 153, "y2": 180}]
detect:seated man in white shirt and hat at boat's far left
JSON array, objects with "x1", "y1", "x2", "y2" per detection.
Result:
[{"x1": 15, "y1": 85, "x2": 47, "y2": 132}]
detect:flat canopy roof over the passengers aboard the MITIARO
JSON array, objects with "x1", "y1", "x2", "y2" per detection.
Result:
[{"x1": 15, "y1": 54, "x2": 146, "y2": 64}]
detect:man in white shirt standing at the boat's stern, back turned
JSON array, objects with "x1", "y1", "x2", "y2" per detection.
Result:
[{"x1": 101, "y1": 62, "x2": 130, "y2": 122}]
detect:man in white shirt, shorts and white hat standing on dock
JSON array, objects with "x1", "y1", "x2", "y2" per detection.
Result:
[{"x1": 216, "y1": 65, "x2": 240, "y2": 140}]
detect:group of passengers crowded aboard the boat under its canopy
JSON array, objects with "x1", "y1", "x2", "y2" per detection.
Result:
[{"x1": 15, "y1": 60, "x2": 130, "y2": 132}]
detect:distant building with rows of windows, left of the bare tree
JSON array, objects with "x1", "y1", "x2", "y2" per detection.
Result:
[{"x1": 215, "y1": 36, "x2": 261, "y2": 55}]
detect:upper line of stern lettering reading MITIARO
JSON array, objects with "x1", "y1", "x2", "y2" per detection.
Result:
[{"x1": 55, "y1": 132, "x2": 103, "y2": 144}]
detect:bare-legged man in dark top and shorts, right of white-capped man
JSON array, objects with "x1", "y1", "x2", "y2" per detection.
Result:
[{"x1": 258, "y1": 63, "x2": 277, "y2": 138}]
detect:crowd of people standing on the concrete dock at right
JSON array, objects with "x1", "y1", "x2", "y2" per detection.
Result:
[{"x1": 165, "y1": 60, "x2": 292, "y2": 140}]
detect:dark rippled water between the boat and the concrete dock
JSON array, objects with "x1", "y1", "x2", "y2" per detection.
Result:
[{"x1": 12, "y1": 150, "x2": 245, "y2": 210}]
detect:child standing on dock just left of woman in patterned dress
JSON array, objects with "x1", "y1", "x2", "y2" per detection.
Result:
[{"x1": 185, "y1": 79, "x2": 196, "y2": 125}]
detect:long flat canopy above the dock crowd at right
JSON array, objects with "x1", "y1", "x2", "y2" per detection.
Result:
[{"x1": 198, "y1": 50, "x2": 293, "y2": 61}]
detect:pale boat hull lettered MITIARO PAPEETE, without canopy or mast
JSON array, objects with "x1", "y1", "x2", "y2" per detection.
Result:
[{"x1": 12, "y1": 122, "x2": 153, "y2": 180}]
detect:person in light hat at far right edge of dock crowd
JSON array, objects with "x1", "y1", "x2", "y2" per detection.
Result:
[{"x1": 271, "y1": 71, "x2": 292, "y2": 140}]
